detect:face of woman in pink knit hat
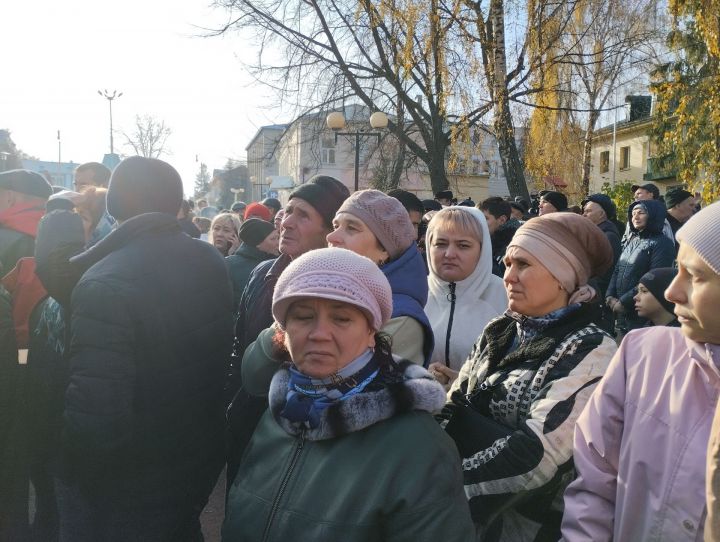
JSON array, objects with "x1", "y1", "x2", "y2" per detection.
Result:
[{"x1": 285, "y1": 298, "x2": 375, "y2": 378}]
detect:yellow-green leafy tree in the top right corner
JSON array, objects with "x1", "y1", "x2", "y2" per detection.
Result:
[{"x1": 652, "y1": 0, "x2": 720, "y2": 202}]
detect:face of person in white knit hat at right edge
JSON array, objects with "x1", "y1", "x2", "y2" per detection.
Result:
[{"x1": 665, "y1": 242, "x2": 720, "y2": 344}]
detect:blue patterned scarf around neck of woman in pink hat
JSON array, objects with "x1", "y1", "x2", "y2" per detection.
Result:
[{"x1": 280, "y1": 349, "x2": 379, "y2": 429}]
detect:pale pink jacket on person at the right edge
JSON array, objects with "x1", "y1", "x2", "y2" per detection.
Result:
[{"x1": 562, "y1": 326, "x2": 720, "y2": 542}]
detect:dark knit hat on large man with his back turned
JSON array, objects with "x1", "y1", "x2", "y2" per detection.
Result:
[{"x1": 107, "y1": 156, "x2": 183, "y2": 220}]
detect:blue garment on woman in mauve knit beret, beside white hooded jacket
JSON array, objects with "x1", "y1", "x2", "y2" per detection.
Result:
[{"x1": 380, "y1": 243, "x2": 435, "y2": 367}]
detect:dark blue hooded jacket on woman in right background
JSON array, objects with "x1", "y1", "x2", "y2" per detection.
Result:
[{"x1": 607, "y1": 200, "x2": 675, "y2": 312}]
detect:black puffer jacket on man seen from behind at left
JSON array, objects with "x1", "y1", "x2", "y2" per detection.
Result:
[{"x1": 61, "y1": 213, "x2": 232, "y2": 506}]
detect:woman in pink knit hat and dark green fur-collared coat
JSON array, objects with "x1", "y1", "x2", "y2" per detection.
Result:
[{"x1": 223, "y1": 248, "x2": 474, "y2": 542}]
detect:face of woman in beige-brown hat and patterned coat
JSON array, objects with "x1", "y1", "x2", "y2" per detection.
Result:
[{"x1": 503, "y1": 247, "x2": 569, "y2": 316}]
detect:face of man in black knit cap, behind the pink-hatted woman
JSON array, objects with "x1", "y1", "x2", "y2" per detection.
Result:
[{"x1": 280, "y1": 198, "x2": 329, "y2": 258}]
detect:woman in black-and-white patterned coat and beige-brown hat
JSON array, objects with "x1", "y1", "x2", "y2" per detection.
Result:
[{"x1": 440, "y1": 213, "x2": 617, "y2": 542}]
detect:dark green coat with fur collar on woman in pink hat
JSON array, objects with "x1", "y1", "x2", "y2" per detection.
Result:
[{"x1": 222, "y1": 361, "x2": 475, "y2": 542}]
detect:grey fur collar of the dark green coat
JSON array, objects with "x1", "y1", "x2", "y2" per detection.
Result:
[{"x1": 269, "y1": 361, "x2": 446, "y2": 440}]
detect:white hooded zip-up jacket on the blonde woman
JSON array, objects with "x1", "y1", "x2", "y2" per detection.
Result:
[{"x1": 425, "y1": 207, "x2": 508, "y2": 370}]
